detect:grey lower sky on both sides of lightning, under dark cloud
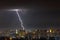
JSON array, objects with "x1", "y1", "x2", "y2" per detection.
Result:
[{"x1": 0, "y1": 9, "x2": 60, "y2": 30}]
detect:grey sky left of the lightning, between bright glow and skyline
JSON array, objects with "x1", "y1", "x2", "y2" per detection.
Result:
[{"x1": 0, "y1": 11, "x2": 20, "y2": 30}]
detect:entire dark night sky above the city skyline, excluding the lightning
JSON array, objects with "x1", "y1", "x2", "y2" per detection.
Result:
[{"x1": 0, "y1": 0, "x2": 60, "y2": 30}]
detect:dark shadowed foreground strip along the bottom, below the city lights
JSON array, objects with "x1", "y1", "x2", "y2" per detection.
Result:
[{"x1": 0, "y1": 37, "x2": 59, "y2": 40}]
